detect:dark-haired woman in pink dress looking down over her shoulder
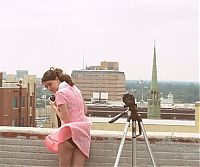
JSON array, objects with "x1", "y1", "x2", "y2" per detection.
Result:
[{"x1": 42, "y1": 68, "x2": 91, "y2": 167}]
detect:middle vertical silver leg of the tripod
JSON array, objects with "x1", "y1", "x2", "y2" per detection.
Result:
[{"x1": 132, "y1": 121, "x2": 136, "y2": 167}]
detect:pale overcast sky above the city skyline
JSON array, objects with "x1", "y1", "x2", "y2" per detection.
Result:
[{"x1": 0, "y1": 0, "x2": 199, "y2": 82}]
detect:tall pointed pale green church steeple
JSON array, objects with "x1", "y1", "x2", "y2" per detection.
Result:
[{"x1": 147, "y1": 42, "x2": 160, "y2": 119}]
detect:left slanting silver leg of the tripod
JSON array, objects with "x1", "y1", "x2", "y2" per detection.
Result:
[{"x1": 114, "y1": 122, "x2": 130, "y2": 167}]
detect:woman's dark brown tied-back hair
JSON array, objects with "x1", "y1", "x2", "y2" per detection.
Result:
[{"x1": 42, "y1": 67, "x2": 74, "y2": 86}]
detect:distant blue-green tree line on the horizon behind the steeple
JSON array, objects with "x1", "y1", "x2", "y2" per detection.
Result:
[{"x1": 126, "y1": 80, "x2": 200, "y2": 103}]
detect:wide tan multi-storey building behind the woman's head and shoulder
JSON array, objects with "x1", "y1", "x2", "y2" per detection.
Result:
[{"x1": 71, "y1": 62, "x2": 125, "y2": 102}]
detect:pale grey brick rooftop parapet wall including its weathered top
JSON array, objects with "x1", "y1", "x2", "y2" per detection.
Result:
[{"x1": 0, "y1": 126, "x2": 200, "y2": 167}]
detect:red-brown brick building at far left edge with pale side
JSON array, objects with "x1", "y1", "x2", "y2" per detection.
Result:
[{"x1": 0, "y1": 73, "x2": 36, "y2": 126}]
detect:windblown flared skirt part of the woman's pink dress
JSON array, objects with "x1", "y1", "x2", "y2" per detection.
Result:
[{"x1": 45, "y1": 122, "x2": 91, "y2": 157}]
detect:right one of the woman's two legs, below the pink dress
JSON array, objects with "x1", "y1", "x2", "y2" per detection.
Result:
[{"x1": 72, "y1": 148, "x2": 86, "y2": 167}]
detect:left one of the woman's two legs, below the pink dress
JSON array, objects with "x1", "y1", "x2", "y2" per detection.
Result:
[{"x1": 58, "y1": 141, "x2": 75, "y2": 167}]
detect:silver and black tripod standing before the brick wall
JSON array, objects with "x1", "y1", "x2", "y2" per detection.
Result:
[{"x1": 109, "y1": 93, "x2": 156, "y2": 167}]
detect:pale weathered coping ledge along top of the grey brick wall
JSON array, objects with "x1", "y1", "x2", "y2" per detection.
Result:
[{"x1": 0, "y1": 126, "x2": 200, "y2": 143}]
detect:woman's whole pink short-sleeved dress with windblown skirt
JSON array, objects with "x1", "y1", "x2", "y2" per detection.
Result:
[{"x1": 45, "y1": 82, "x2": 91, "y2": 157}]
